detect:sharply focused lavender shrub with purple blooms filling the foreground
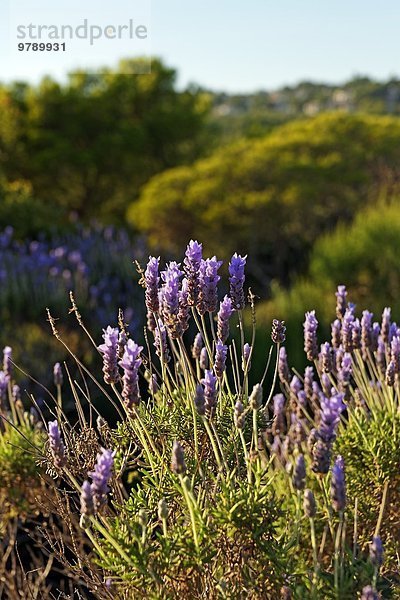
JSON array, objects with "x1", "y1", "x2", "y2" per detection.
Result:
[{"x1": 0, "y1": 241, "x2": 400, "y2": 600}]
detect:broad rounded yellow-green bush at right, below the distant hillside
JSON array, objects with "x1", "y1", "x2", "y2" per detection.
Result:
[{"x1": 133, "y1": 113, "x2": 400, "y2": 287}]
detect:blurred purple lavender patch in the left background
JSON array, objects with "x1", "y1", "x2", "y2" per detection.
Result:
[{"x1": 0, "y1": 226, "x2": 143, "y2": 329}]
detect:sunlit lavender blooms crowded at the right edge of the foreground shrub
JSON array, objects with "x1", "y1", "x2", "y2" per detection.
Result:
[{"x1": 269, "y1": 285, "x2": 400, "y2": 480}]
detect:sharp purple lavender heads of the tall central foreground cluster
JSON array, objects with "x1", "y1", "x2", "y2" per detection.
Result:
[{"x1": 98, "y1": 240, "x2": 250, "y2": 413}]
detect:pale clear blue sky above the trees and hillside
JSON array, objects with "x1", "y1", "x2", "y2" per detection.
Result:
[{"x1": 0, "y1": 0, "x2": 400, "y2": 93}]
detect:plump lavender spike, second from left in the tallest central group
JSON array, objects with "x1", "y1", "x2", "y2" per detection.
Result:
[{"x1": 159, "y1": 261, "x2": 183, "y2": 339}]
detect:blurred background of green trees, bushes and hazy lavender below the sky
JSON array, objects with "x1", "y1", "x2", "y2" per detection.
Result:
[{"x1": 0, "y1": 59, "x2": 400, "y2": 390}]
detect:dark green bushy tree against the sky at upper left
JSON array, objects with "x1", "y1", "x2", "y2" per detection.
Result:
[{"x1": 0, "y1": 60, "x2": 207, "y2": 221}]
